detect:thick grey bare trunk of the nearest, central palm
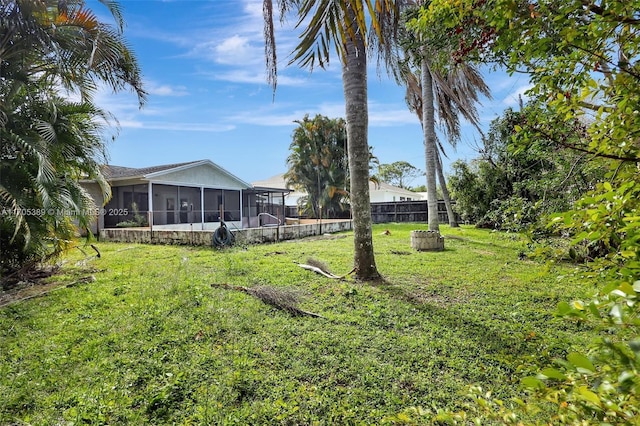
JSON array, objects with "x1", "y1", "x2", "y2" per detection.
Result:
[{"x1": 342, "y1": 22, "x2": 380, "y2": 280}]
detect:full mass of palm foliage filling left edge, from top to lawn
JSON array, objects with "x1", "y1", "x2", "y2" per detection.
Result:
[{"x1": 0, "y1": 0, "x2": 145, "y2": 276}]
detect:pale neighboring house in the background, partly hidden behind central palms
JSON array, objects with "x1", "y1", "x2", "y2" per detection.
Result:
[{"x1": 253, "y1": 174, "x2": 426, "y2": 216}]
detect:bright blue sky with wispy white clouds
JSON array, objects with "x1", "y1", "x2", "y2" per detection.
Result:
[{"x1": 88, "y1": 0, "x2": 528, "y2": 185}]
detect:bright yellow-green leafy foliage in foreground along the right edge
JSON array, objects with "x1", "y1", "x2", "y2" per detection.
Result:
[{"x1": 413, "y1": 0, "x2": 640, "y2": 424}]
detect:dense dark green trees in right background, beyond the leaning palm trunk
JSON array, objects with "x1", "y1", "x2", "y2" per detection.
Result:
[{"x1": 450, "y1": 106, "x2": 603, "y2": 231}]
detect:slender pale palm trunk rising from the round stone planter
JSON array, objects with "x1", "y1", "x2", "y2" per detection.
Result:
[{"x1": 421, "y1": 58, "x2": 440, "y2": 231}]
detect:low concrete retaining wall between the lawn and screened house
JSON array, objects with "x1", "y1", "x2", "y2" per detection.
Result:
[{"x1": 100, "y1": 220, "x2": 352, "y2": 246}]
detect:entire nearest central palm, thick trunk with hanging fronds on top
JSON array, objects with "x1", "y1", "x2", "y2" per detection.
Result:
[{"x1": 263, "y1": 0, "x2": 399, "y2": 280}]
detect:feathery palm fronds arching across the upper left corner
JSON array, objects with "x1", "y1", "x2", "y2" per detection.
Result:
[{"x1": 0, "y1": 0, "x2": 146, "y2": 105}]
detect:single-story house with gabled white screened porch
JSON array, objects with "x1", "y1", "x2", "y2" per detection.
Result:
[{"x1": 83, "y1": 160, "x2": 288, "y2": 233}]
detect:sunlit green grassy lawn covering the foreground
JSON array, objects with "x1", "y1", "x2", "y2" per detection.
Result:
[{"x1": 0, "y1": 224, "x2": 593, "y2": 425}]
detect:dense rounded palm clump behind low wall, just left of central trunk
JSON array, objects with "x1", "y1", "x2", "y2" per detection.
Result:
[{"x1": 285, "y1": 115, "x2": 348, "y2": 218}]
